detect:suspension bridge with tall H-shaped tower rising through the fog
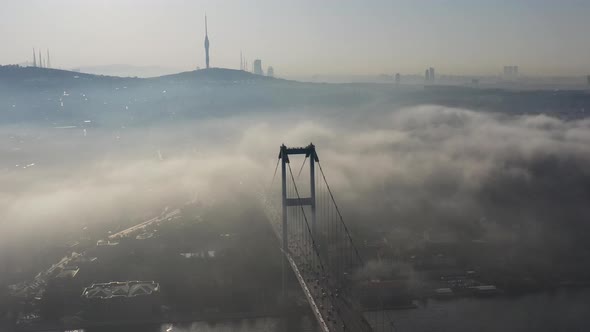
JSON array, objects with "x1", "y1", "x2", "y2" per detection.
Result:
[{"x1": 261, "y1": 144, "x2": 394, "y2": 332}]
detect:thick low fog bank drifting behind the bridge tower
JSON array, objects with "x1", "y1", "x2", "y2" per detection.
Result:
[{"x1": 0, "y1": 105, "x2": 590, "y2": 256}]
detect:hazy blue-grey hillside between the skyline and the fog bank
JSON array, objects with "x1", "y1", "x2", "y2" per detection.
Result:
[{"x1": 0, "y1": 66, "x2": 590, "y2": 126}]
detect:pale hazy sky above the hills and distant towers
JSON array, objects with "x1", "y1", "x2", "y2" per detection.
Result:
[{"x1": 0, "y1": 0, "x2": 590, "y2": 76}]
